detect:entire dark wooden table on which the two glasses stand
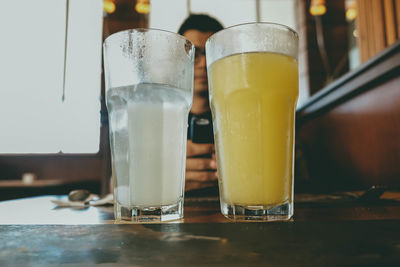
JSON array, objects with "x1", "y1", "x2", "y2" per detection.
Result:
[{"x1": 0, "y1": 192, "x2": 400, "y2": 266}]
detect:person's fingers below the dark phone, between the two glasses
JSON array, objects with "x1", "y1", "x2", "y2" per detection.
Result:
[{"x1": 185, "y1": 140, "x2": 218, "y2": 191}]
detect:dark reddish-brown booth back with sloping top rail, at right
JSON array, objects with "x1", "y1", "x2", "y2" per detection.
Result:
[{"x1": 296, "y1": 41, "x2": 400, "y2": 190}]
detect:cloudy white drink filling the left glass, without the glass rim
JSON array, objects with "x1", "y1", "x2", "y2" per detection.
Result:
[{"x1": 107, "y1": 84, "x2": 191, "y2": 222}]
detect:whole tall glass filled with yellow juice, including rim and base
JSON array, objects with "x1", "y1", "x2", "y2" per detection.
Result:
[{"x1": 206, "y1": 23, "x2": 298, "y2": 221}]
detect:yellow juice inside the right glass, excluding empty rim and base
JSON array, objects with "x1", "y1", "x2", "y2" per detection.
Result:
[{"x1": 208, "y1": 52, "x2": 298, "y2": 207}]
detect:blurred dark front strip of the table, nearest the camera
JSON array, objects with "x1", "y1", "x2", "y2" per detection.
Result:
[{"x1": 0, "y1": 221, "x2": 400, "y2": 267}]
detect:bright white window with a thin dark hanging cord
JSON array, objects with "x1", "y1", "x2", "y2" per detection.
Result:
[{"x1": 0, "y1": 0, "x2": 102, "y2": 154}]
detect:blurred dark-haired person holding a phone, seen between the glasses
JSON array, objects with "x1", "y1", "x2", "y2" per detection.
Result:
[{"x1": 178, "y1": 14, "x2": 223, "y2": 191}]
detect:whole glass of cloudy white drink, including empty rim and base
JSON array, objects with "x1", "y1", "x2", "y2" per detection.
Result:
[{"x1": 104, "y1": 29, "x2": 194, "y2": 222}]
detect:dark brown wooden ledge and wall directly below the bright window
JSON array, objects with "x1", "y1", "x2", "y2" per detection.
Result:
[{"x1": 0, "y1": 154, "x2": 105, "y2": 200}]
